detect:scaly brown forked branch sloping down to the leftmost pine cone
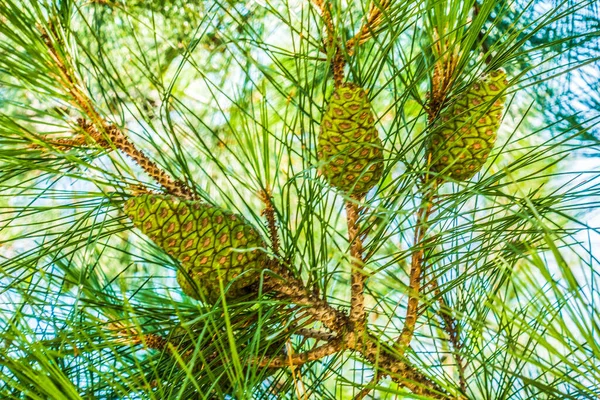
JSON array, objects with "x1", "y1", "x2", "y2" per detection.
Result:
[{"x1": 38, "y1": 22, "x2": 197, "y2": 200}]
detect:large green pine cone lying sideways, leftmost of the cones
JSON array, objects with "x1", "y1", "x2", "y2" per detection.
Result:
[{"x1": 124, "y1": 194, "x2": 267, "y2": 303}]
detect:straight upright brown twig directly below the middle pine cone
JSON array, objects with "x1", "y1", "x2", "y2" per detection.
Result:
[{"x1": 346, "y1": 201, "x2": 366, "y2": 332}]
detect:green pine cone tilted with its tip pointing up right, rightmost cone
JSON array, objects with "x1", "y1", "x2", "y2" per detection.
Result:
[{"x1": 427, "y1": 69, "x2": 508, "y2": 181}]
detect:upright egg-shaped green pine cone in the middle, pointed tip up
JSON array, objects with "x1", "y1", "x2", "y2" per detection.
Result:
[{"x1": 317, "y1": 83, "x2": 383, "y2": 196}]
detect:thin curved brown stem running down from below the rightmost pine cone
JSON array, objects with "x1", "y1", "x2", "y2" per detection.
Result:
[{"x1": 398, "y1": 185, "x2": 435, "y2": 351}]
